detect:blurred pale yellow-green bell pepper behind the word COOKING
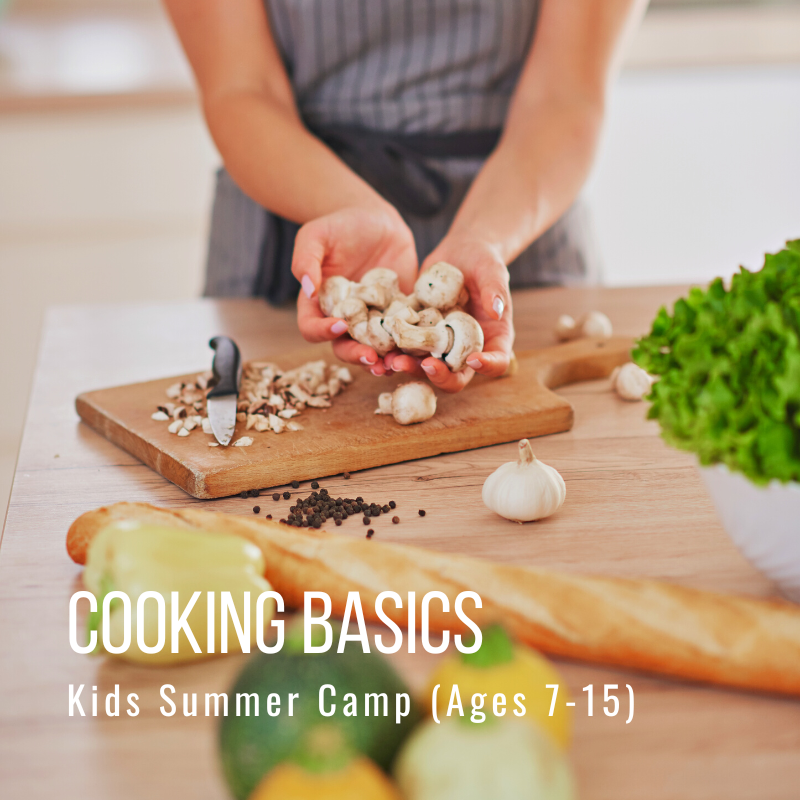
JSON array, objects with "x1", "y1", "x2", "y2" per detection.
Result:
[{"x1": 83, "y1": 521, "x2": 275, "y2": 665}]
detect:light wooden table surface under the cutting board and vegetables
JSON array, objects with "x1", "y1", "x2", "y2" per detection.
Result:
[{"x1": 0, "y1": 287, "x2": 800, "y2": 800}]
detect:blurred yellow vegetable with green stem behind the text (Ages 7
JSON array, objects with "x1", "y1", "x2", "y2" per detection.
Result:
[{"x1": 427, "y1": 625, "x2": 572, "y2": 748}]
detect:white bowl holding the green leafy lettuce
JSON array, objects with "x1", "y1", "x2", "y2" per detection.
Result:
[{"x1": 700, "y1": 464, "x2": 800, "y2": 603}]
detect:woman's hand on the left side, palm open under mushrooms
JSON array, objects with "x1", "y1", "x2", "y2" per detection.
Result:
[{"x1": 292, "y1": 206, "x2": 418, "y2": 375}]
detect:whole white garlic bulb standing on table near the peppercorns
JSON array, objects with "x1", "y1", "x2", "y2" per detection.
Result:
[{"x1": 483, "y1": 439, "x2": 567, "y2": 522}]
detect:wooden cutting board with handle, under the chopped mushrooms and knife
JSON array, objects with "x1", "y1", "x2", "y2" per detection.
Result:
[{"x1": 75, "y1": 337, "x2": 633, "y2": 499}]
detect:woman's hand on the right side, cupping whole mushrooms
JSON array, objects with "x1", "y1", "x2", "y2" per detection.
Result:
[{"x1": 384, "y1": 235, "x2": 514, "y2": 392}]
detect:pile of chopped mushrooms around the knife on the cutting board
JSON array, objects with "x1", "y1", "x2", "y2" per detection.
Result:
[{"x1": 152, "y1": 361, "x2": 353, "y2": 447}]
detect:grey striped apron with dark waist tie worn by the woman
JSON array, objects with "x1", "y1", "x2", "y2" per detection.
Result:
[{"x1": 205, "y1": 0, "x2": 598, "y2": 304}]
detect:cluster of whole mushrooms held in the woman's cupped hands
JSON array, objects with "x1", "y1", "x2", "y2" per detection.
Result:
[{"x1": 319, "y1": 261, "x2": 483, "y2": 372}]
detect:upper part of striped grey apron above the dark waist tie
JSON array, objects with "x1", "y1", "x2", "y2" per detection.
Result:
[{"x1": 266, "y1": 0, "x2": 539, "y2": 133}]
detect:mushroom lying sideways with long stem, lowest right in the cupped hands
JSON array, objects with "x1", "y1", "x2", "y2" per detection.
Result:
[{"x1": 393, "y1": 311, "x2": 483, "y2": 372}]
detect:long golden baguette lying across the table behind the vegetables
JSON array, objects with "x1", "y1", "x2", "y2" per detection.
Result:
[{"x1": 67, "y1": 503, "x2": 800, "y2": 696}]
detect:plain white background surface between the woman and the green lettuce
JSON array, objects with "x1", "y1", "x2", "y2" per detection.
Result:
[{"x1": 586, "y1": 65, "x2": 800, "y2": 285}]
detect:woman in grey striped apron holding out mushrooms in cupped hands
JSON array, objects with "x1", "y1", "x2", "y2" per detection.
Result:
[{"x1": 165, "y1": 0, "x2": 646, "y2": 391}]
